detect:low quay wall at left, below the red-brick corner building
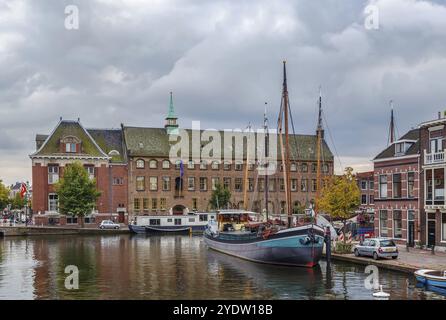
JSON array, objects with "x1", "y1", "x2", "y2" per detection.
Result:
[{"x1": 0, "y1": 226, "x2": 130, "y2": 237}]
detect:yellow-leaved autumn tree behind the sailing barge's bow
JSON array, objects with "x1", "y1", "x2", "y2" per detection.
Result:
[{"x1": 318, "y1": 167, "x2": 361, "y2": 243}]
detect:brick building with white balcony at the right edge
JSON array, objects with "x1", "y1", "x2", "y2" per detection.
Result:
[{"x1": 419, "y1": 117, "x2": 446, "y2": 250}]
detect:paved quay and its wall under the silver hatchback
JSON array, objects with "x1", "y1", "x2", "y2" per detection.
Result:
[{"x1": 324, "y1": 248, "x2": 446, "y2": 274}]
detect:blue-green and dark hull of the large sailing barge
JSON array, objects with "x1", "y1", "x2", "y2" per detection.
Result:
[{"x1": 204, "y1": 228, "x2": 324, "y2": 267}]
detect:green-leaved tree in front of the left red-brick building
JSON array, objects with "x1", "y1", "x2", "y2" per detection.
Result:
[{"x1": 56, "y1": 162, "x2": 101, "y2": 227}]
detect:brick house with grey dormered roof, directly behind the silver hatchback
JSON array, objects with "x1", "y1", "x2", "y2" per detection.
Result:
[{"x1": 373, "y1": 129, "x2": 423, "y2": 246}]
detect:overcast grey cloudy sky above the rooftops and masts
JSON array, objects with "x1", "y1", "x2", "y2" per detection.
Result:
[{"x1": 0, "y1": 0, "x2": 446, "y2": 183}]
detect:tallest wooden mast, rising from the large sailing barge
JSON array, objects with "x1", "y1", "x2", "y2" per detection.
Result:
[{"x1": 282, "y1": 61, "x2": 292, "y2": 228}]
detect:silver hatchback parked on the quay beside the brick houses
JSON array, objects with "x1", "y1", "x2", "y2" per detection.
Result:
[{"x1": 353, "y1": 238, "x2": 398, "y2": 260}]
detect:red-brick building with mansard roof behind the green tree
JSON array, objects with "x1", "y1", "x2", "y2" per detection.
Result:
[{"x1": 30, "y1": 119, "x2": 128, "y2": 225}]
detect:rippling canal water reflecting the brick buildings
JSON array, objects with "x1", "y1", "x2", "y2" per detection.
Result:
[{"x1": 0, "y1": 235, "x2": 446, "y2": 300}]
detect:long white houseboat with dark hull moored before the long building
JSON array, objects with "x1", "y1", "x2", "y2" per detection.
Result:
[{"x1": 129, "y1": 212, "x2": 217, "y2": 233}]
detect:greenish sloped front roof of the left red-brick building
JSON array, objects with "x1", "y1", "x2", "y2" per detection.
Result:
[{"x1": 30, "y1": 120, "x2": 109, "y2": 158}]
